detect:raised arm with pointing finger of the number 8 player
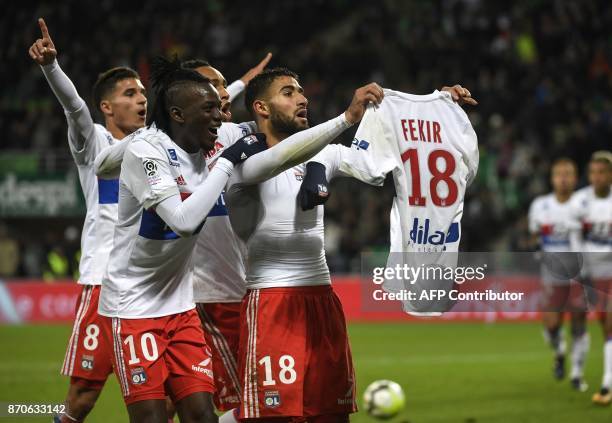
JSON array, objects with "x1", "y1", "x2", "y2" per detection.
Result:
[{"x1": 29, "y1": 18, "x2": 94, "y2": 151}]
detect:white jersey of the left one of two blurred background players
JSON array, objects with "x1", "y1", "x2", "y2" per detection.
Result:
[{"x1": 528, "y1": 193, "x2": 580, "y2": 252}]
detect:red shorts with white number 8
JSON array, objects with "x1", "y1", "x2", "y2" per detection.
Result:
[{"x1": 62, "y1": 285, "x2": 113, "y2": 389}]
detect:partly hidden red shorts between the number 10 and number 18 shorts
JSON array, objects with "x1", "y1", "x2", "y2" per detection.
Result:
[{"x1": 196, "y1": 303, "x2": 242, "y2": 411}]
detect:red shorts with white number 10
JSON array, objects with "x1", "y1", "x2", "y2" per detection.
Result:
[{"x1": 104, "y1": 310, "x2": 215, "y2": 405}]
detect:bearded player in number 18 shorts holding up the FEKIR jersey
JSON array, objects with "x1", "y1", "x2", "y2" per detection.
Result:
[{"x1": 226, "y1": 69, "x2": 382, "y2": 422}]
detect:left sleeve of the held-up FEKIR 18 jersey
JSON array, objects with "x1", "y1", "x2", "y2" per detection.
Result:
[{"x1": 309, "y1": 106, "x2": 398, "y2": 186}]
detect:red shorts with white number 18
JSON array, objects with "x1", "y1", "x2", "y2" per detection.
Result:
[{"x1": 238, "y1": 285, "x2": 357, "y2": 419}]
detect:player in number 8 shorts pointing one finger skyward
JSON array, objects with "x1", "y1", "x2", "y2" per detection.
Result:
[{"x1": 29, "y1": 19, "x2": 147, "y2": 422}]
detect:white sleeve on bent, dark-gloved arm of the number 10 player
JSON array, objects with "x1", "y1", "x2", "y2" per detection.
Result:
[{"x1": 155, "y1": 158, "x2": 233, "y2": 237}]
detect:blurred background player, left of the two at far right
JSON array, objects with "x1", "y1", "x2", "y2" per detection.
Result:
[{"x1": 529, "y1": 158, "x2": 589, "y2": 391}]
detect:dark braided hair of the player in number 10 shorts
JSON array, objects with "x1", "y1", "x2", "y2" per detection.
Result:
[{"x1": 147, "y1": 56, "x2": 210, "y2": 136}]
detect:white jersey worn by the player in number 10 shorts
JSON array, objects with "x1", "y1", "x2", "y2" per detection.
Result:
[{"x1": 98, "y1": 128, "x2": 208, "y2": 318}]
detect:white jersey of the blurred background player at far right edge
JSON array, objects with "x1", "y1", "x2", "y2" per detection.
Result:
[{"x1": 571, "y1": 186, "x2": 612, "y2": 278}]
